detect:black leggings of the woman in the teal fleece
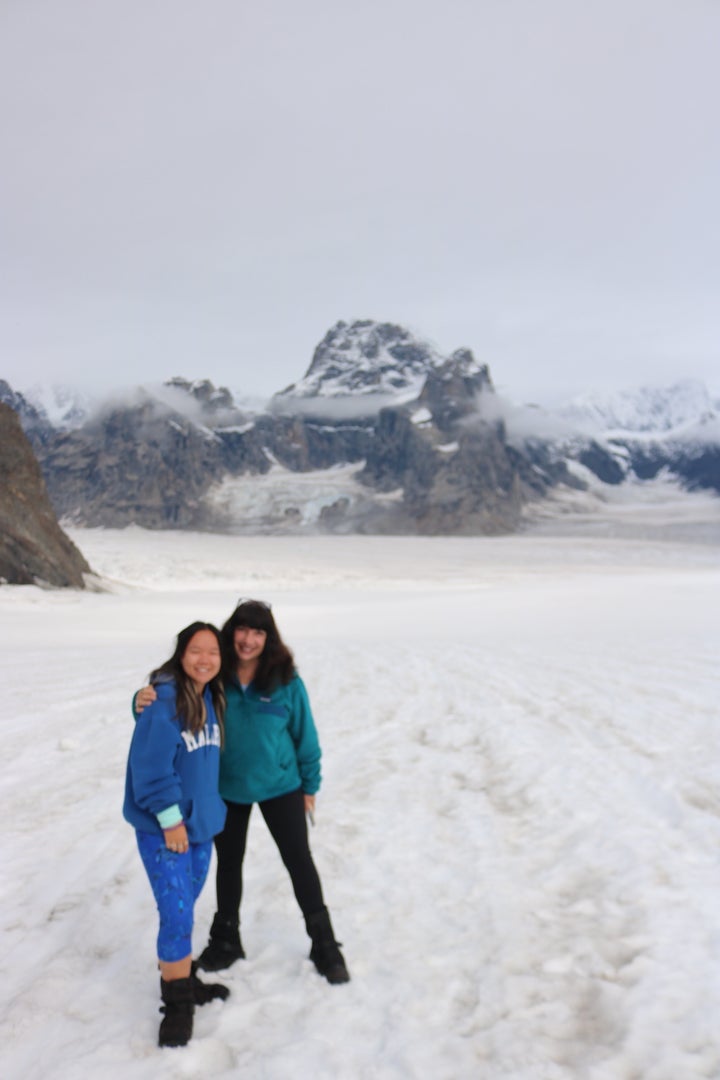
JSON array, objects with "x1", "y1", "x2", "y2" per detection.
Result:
[{"x1": 215, "y1": 788, "x2": 325, "y2": 922}]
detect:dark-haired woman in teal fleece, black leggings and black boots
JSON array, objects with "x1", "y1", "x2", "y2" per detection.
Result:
[{"x1": 137, "y1": 600, "x2": 350, "y2": 984}]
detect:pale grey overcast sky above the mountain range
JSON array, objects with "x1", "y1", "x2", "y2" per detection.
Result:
[{"x1": 0, "y1": 0, "x2": 720, "y2": 401}]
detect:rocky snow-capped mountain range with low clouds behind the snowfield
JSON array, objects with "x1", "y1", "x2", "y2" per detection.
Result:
[{"x1": 0, "y1": 320, "x2": 720, "y2": 534}]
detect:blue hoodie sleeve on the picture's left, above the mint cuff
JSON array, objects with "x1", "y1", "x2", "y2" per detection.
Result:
[{"x1": 128, "y1": 700, "x2": 182, "y2": 814}]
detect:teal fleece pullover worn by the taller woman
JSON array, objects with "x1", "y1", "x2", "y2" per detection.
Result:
[{"x1": 220, "y1": 675, "x2": 321, "y2": 804}]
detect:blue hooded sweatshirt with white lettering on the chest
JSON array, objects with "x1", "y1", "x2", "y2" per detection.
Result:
[{"x1": 123, "y1": 683, "x2": 226, "y2": 843}]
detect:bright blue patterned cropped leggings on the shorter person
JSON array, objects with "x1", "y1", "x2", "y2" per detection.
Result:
[{"x1": 135, "y1": 831, "x2": 213, "y2": 963}]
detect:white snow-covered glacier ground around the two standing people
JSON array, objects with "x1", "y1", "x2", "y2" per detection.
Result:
[{"x1": 0, "y1": 500, "x2": 720, "y2": 1080}]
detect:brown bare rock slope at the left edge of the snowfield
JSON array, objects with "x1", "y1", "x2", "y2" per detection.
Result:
[{"x1": 0, "y1": 403, "x2": 91, "y2": 589}]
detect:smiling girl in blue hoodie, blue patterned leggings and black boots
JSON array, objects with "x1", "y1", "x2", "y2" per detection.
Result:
[{"x1": 123, "y1": 622, "x2": 229, "y2": 1047}]
